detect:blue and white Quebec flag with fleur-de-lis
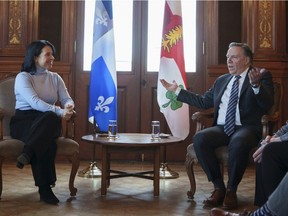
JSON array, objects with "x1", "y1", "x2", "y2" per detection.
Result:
[{"x1": 88, "y1": 0, "x2": 117, "y2": 132}]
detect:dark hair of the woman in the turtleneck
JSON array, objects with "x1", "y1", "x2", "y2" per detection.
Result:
[{"x1": 21, "y1": 40, "x2": 56, "y2": 74}]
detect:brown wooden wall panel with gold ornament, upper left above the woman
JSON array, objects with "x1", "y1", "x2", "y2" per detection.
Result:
[{"x1": 0, "y1": 1, "x2": 38, "y2": 60}]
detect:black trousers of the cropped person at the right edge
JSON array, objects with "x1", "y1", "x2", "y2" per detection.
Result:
[{"x1": 254, "y1": 142, "x2": 288, "y2": 206}]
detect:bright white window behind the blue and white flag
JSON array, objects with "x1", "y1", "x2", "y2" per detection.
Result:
[{"x1": 83, "y1": 0, "x2": 133, "y2": 71}]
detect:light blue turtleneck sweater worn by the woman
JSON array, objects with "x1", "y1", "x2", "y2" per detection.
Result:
[{"x1": 14, "y1": 67, "x2": 74, "y2": 117}]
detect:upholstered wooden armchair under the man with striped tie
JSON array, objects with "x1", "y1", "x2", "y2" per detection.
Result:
[{"x1": 185, "y1": 83, "x2": 282, "y2": 199}]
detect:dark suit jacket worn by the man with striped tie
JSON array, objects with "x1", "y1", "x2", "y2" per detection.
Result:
[{"x1": 177, "y1": 71, "x2": 274, "y2": 127}]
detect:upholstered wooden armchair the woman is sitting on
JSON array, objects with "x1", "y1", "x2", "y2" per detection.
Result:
[{"x1": 0, "y1": 74, "x2": 80, "y2": 199}]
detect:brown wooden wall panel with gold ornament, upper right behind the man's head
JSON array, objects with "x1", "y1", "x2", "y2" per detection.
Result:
[{"x1": 242, "y1": 0, "x2": 287, "y2": 61}]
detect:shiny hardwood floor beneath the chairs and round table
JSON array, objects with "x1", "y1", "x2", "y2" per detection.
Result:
[{"x1": 0, "y1": 161, "x2": 255, "y2": 216}]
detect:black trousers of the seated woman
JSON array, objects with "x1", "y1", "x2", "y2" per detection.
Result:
[{"x1": 10, "y1": 110, "x2": 61, "y2": 186}]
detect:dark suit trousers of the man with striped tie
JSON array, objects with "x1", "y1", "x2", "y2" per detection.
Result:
[{"x1": 193, "y1": 126, "x2": 261, "y2": 191}]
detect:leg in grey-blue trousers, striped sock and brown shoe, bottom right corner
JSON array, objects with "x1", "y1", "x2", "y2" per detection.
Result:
[{"x1": 210, "y1": 173, "x2": 288, "y2": 216}]
